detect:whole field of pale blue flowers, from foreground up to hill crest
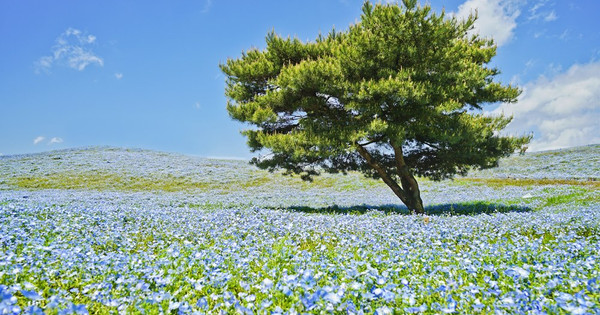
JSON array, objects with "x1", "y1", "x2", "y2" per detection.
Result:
[{"x1": 0, "y1": 145, "x2": 600, "y2": 314}]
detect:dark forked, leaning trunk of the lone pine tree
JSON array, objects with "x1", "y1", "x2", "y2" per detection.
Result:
[{"x1": 356, "y1": 143, "x2": 425, "y2": 214}]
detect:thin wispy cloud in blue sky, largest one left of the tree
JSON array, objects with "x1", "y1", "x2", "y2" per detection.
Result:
[{"x1": 35, "y1": 28, "x2": 104, "y2": 73}]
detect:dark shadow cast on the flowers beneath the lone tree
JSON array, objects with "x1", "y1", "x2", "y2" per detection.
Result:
[{"x1": 283, "y1": 201, "x2": 533, "y2": 216}]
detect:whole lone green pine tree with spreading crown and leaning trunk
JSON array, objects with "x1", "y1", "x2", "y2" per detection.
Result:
[{"x1": 220, "y1": 0, "x2": 530, "y2": 212}]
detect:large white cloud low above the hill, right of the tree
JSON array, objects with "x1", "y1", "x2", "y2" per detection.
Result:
[{"x1": 494, "y1": 62, "x2": 600, "y2": 151}]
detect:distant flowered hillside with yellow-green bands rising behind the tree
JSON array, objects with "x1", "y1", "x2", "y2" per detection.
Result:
[{"x1": 0, "y1": 145, "x2": 600, "y2": 212}]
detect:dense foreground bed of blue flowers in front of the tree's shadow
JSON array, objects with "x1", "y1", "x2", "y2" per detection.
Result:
[{"x1": 0, "y1": 191, "x2": 600, "y2": 314}]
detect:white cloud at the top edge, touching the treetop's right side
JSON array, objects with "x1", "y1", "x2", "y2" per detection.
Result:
[{"x1": 455, "y1": 0, "x2": 521, "y2": 46}]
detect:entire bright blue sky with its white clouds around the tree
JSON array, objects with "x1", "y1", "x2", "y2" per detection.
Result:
[{"x1": 0, "y1": 0, "x2": 600, "y2": 159}]
